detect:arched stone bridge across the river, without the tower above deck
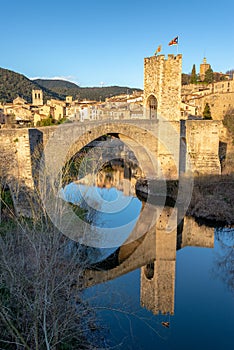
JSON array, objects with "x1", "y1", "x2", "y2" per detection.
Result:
[{"x1": 0, "y1": 118, "x2": 221, "y2": 216}]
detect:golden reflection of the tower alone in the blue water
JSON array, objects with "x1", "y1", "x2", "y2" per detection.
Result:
[{"x1": 141, "y1": 207, "x2": 177, "y2": 314}]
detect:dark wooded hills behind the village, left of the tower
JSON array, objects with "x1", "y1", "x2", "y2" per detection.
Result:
[{"x1": 0, "y1": 68, "x2": 141, "y2": 103}]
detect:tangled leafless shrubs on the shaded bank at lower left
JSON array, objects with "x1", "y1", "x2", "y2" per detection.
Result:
[{"x1": 0, "y1": 144, "x2": 100, "y2": 350}]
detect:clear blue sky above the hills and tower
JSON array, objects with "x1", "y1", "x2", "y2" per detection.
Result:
[{"x1": 0, "y1": 0, "x2": 234, "y2": 88}]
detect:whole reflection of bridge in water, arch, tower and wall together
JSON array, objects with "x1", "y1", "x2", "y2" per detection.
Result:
[{"x1": 85, "y1": 206, "x2": 214, "y2": 314}]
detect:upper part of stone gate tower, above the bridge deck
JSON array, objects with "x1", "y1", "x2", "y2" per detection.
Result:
[{"x1": 143, "y1": 55, "x2": 182, "y2": 121}]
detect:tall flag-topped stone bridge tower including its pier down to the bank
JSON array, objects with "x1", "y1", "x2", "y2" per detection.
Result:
[{"x1": 143, "y1": 55, "x2": 182, "y2": 180}]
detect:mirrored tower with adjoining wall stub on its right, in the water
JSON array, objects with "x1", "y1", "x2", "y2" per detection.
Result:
[{"x1": 141, "y1": 207, "x2": 214, "y2": 315}]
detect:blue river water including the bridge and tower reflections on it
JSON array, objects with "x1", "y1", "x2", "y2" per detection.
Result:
[{"x1": 62, "y1": 179, "x2": 234, "y2": 350}]
